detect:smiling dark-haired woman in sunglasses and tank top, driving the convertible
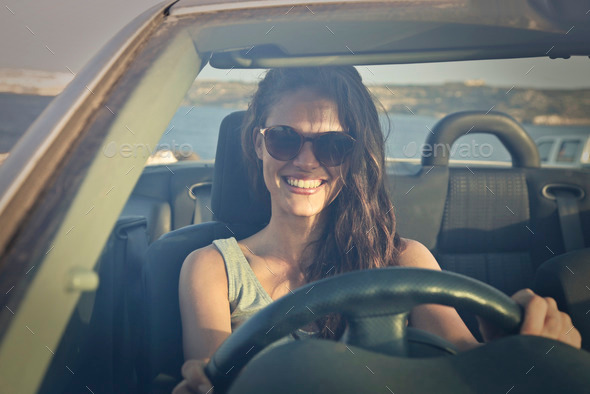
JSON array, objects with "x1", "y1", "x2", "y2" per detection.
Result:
[{"x1": 175, "y1": 66, "x2": 580, "y2": 393}]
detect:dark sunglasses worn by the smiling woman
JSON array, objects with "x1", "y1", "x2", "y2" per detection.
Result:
[{"x1": 258, "y1": 126, "x2": 356, "y2": 167}]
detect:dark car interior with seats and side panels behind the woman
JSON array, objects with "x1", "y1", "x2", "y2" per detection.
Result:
[{"x1": 39, "y1": 105, "x2": 590, "y2": 392}]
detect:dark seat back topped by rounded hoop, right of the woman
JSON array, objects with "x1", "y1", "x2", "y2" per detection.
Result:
[{"x1": 422, "y1": 111, "x2": 540, "y2": 339}]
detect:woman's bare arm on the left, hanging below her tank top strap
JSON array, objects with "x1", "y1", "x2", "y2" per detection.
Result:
[{"x1": 174, "y1": 245, "x2": 231, "y2": 393}]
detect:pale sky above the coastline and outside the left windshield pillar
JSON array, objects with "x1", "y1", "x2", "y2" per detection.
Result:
[{"x1": 0, "y1": 0, "x2": 590, "y2": 88}]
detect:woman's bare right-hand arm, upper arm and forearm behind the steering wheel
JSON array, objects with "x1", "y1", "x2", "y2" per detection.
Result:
[{"x1": 399, "y1": 239, "x2": 480, "y2": 350}]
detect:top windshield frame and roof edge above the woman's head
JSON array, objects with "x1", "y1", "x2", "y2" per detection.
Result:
[{"x1": 169, "y1": 0, "x2": 590, "y2": 69}]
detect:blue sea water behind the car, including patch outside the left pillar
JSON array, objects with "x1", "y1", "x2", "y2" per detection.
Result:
[{"x1": 0, "y1": 93, "x2": 590, "y2": 161}]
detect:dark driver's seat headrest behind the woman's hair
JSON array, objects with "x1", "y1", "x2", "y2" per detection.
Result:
[{"x1": 211, "y1": 111, "x2": 271, "y2": 226}]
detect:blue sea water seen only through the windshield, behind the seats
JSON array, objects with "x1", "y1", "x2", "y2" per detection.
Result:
[{"x1": 158, "y1": 106, "x2": 590, "y2": 161}]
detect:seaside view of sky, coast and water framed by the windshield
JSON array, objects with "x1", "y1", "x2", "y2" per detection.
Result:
[{"x1": 154, "y1": 57, "x2": 590, "y2": 167}]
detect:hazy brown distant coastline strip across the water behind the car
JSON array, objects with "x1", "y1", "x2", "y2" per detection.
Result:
[{"x1": 0, "y1": 69, "x2": 590, "y2": 126}]
